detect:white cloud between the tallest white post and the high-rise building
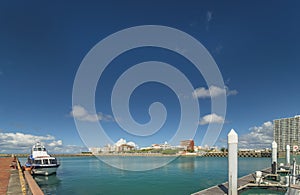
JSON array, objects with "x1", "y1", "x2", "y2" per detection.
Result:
[{"x1": 239, "y1": 121, "x2": 273, "y2": 149}]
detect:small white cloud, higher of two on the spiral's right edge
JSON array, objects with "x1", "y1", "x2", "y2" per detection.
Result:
[{"x1": 193, "y1": 85, "x2": 238, "y2": 98}]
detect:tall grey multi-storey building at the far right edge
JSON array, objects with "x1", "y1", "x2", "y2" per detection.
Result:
[{"x1": 273, "y1": 115, "x2": 300, "y2": 151}]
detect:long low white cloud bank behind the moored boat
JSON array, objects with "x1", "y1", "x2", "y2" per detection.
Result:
[{"x1": 0, "y1": 132, "x2": 87, "y2": 154}]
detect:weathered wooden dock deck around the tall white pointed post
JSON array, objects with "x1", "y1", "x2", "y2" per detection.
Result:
[{"x1": 192, "y1": 168, "x2": 271, "y2": 195}]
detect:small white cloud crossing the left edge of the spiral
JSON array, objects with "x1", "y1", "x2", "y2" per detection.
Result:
[{"x1": 70, "y1": 105, "x2": 114, "y2": 122}]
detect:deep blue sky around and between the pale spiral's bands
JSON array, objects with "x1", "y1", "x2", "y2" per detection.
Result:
[{"x1": 0, "y1": 1, "x2": 300, "y2": 152}]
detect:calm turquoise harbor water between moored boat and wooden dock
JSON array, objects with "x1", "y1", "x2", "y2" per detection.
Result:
[{"x1": 20, "y1": 156, "x2": 271, "y2": 195}]
